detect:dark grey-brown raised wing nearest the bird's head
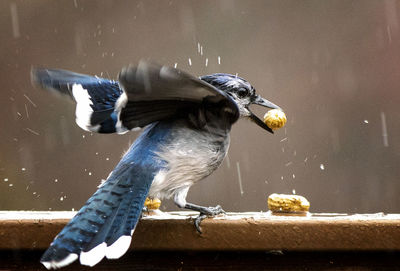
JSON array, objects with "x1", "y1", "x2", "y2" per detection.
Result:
[{"x1": 116, "y1": 61, "x2": 239, "y2": 130}]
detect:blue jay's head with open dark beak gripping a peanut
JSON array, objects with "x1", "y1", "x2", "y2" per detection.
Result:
[{"x1": 200, "y1": 73, "x2": 281, "y2": 133}]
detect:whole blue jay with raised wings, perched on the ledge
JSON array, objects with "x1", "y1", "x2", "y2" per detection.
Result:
[{"x1": 32, "y1": 61, "x2": 279, "y2": 269}]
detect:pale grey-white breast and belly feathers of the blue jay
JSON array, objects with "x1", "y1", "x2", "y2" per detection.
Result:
[{"x1": 149, "y1": 124, "x2": 229, "y2": 199}]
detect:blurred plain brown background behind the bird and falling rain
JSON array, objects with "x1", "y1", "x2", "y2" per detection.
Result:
[{"x1": 0, "y1": 0, "x2": 400, "y2": 213}]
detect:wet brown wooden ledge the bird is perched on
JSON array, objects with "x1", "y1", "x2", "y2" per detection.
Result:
[{"x1": 0, "y1": 211, "x2": 400, "y2": 251}]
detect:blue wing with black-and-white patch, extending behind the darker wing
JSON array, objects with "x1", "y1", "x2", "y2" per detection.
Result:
[{"x1": 31, "y1": 68, "x2": 125, "y2": 133}]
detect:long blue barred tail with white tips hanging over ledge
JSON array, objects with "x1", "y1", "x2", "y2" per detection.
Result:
[{"x1": 41, "y1": 125, "x2": 165, "y2": 269}]
